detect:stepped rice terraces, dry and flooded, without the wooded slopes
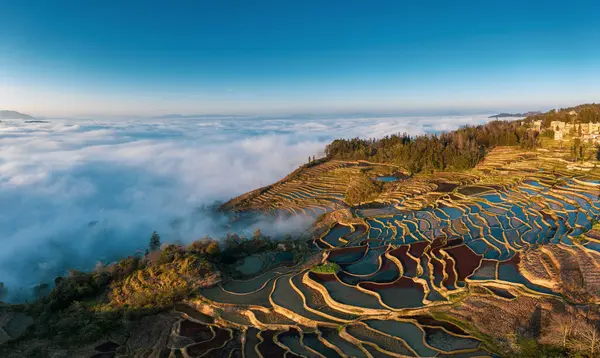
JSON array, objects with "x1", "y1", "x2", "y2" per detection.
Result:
[{"x1": 182, "y1": 148, "x2": 600, "y2": 357}]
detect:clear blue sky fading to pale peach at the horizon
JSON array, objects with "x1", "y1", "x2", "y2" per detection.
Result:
[{"x1": 0, "y1": 0, "x2": 600, "y2": 116}]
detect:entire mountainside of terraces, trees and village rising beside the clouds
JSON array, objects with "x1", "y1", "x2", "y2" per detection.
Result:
[{"x1": 0, "y1": 105, "x2": 600, "y2": 358}]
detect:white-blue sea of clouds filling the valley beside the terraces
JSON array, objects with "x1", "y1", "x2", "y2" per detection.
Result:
[{"x1": 0, "y1": 115, "x2": 488, "y2": 299}]
